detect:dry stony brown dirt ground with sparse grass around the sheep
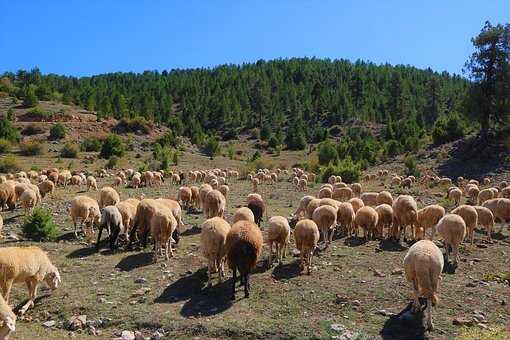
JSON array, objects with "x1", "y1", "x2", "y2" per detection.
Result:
[{"x1": 1, "y1": 154, "x2": 510, "y2": 339}]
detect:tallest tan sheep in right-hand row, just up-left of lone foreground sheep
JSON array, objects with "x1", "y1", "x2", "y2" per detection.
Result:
[{"x1": 391, "y1": 195, "x2": 418, "y2": 241}]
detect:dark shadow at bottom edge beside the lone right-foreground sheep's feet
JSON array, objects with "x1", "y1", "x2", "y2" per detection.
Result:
[{"x1": 379, "y1": 298, "x2": 428, "y2": 340}]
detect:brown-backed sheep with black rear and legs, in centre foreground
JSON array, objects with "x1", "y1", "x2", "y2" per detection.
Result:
[{"x1": 225, "y1": 221, "x2": 263, "y2": 300}]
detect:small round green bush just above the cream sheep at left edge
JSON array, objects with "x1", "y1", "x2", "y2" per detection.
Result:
[{"x1": 22, "y1": 207, "x2": 60, "y2": 241}]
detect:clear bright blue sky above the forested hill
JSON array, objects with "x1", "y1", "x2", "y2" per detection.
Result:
[{"x1": 0, "y1": 0, "x2": 510, "y2": 76}]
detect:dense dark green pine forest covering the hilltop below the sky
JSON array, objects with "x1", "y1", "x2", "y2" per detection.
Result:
[{"x1": 0, "y1": 58, "x2": 468, "y2": 141}]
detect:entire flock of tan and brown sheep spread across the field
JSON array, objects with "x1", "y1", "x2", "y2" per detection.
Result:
[{"x1": 0, "y1": 168, "x2": 510, "y2": 338}]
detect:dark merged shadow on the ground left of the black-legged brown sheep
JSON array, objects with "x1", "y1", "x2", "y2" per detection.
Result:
[{"x1": 154, "y1": 268, "x2": 232, "y2": 317}]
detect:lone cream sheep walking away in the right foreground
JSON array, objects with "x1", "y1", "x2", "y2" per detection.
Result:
[{"x1": 404, "y1": 240, "x2": 444, "y2": 330}]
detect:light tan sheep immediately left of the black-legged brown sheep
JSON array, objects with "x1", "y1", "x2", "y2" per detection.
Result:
[{"x1": 200, "y1": 217, "x2": 230, "y2": 287}]
